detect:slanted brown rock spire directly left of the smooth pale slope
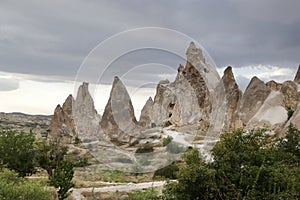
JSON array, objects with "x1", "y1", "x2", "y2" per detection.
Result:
[{"x1": 234, "y1": 76, "x2": 271, "y2": 127}]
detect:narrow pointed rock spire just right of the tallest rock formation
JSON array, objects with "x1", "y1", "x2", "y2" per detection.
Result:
[{"x1": 222, "y1": 66, "x2": 242, "y2": 131}]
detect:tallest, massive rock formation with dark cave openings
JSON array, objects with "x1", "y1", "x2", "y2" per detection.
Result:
[{"x1": 151, "y1": 42, "x2": 220, "y2": 131}]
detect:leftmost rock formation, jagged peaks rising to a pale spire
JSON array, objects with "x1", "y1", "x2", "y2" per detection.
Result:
[{"x1": 48, "y1": 83, "x2": 101, "y2": 142}]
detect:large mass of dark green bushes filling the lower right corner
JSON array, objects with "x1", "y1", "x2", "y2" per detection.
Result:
[{"x1": 134, "y1": 125, "x2": 300, "y2": 200}]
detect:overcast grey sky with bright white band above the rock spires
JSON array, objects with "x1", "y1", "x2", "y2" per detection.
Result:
[{"x1": 0, "y1": 0, "x2": 300, "y2": 114}]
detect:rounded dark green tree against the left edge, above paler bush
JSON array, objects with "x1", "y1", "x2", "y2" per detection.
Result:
[{"x1": 0, "y1": 130, "x2": 36, "y2": 177}]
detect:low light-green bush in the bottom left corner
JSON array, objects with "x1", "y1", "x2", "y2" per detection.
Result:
[{"x1": 0, "y1": 169, "x2": 52, "y2": 200}]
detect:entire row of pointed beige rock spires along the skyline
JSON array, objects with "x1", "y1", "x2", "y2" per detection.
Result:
[{"x1": 48, "y1": 42, "x2": 300, "y2": 144}]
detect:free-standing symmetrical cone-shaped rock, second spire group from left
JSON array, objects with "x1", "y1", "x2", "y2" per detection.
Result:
[{"x1": 100, "y1": 77, "x2": 137, "y2": 143}]
